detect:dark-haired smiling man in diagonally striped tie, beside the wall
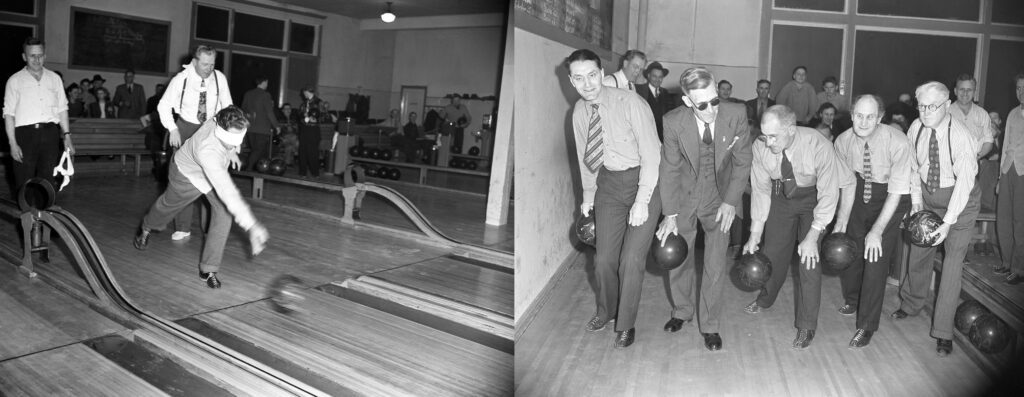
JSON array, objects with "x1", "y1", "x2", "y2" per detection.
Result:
[{"x1": 565, "y1": 49, "x2": 662, "y2": 348}]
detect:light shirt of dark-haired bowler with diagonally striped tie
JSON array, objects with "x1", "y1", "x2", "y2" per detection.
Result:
[{"x1": 572, "y1": 87, "x2": 662, "y2": 204}]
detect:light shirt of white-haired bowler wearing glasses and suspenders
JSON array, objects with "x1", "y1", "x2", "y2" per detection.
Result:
[{"x1": 907, "y1": 115, "x2": 978, "y2": 224}]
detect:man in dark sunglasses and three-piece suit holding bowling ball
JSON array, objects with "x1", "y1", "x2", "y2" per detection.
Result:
[{"x1": 656, "y1": 68, "x2": 751, "y2": 351}]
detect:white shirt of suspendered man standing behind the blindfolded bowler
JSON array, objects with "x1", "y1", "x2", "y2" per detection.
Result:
[{"x1": 157, "y1": 63, "x2": 232, "y2": 131}]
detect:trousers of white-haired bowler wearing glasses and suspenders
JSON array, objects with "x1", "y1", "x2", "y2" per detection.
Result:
[{"x1": 899, "y1": 182, "x2": 981, "y2": 339}]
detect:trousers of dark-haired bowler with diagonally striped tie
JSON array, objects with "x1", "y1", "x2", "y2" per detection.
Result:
[{"x1": 593, "y1": 167, "x2": 662, "y2": 332}]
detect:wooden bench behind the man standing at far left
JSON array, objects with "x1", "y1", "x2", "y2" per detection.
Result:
[{"x1": 70, "y1": 119, "x2": 150, "y2": 176}]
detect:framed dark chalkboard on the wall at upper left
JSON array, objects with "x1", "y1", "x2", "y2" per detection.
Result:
[{"x1": 69, "y1": 7, "x2": 171, "y2": 75}]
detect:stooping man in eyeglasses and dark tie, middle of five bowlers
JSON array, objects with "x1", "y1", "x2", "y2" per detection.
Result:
[{"x1": 743, "y1": 104, "x2": 852, "y2": 349}]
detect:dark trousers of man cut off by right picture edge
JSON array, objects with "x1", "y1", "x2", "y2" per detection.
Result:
[{"x1": 995, "y1": 165, "x2": 1024, "y2": 275}]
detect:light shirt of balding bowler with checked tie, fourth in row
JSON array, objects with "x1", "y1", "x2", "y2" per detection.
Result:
[{"x1": 836, "y1": 124, "x2": 913, "y2": 194}]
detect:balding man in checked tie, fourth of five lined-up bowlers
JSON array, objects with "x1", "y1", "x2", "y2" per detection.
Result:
[{"x1": 833, "y1": 94, "x2": 913, "y2": 348}]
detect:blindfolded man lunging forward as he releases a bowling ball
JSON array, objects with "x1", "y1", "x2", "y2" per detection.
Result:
[{"x1": 134, "y1": 106, "x2": 269, "y2": 289}]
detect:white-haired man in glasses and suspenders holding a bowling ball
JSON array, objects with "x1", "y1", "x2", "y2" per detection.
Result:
[{"x1": 892, "y1": 82, "x2": 981, "y2": 357}]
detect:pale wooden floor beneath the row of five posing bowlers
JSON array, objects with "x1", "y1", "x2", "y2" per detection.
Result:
[{"x1": 515, "y1": 252, "x2": 990, "y2": 396}]
